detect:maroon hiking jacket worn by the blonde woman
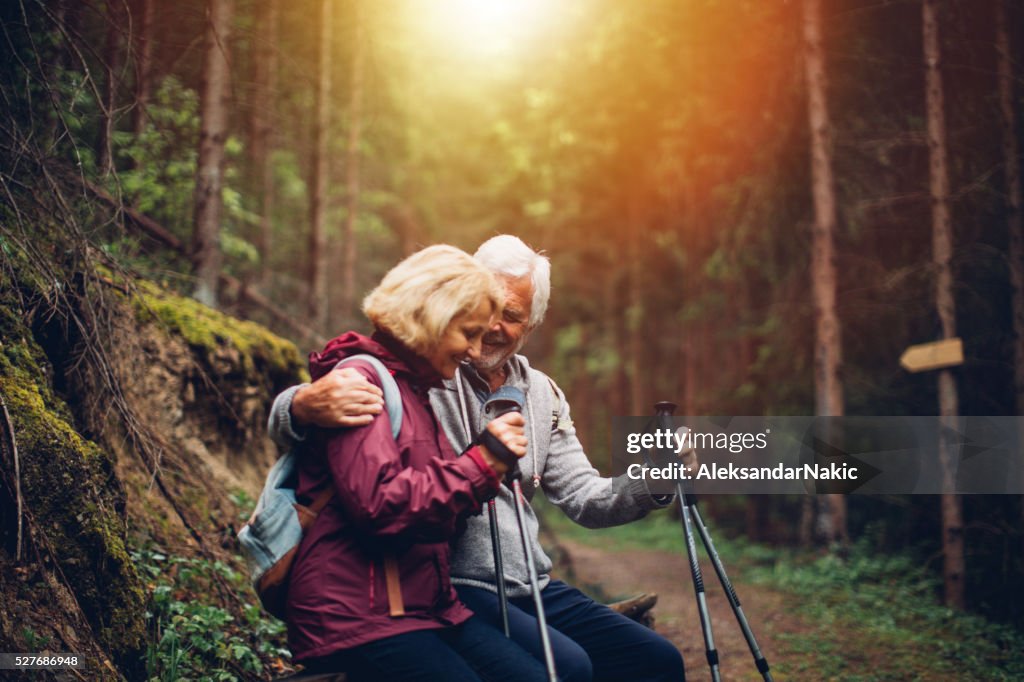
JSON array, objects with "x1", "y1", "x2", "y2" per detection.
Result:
[{"x1": 287, "y1": 332, "x2": 500, "y2": 660}]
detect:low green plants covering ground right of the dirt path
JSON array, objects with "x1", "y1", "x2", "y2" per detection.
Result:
[{"x1": 749, "y1": 538, "x2": 1024, "y2": 680}]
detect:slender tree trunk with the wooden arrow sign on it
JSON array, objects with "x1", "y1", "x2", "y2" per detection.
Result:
[{"x1": 922, "y1": 0, "x2": 964, "y2": 607}]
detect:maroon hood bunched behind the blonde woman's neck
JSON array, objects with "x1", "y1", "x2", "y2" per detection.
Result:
[{"x1": 309, "y1": 330, "x2": 442, "y2": 388}]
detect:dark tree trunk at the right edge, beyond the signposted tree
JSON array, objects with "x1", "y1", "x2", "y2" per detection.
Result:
[{"x1": 995, "y1": 0, "x2": 1024, "y2": 557}]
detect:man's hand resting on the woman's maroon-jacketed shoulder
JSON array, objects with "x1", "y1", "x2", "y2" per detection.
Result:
[{"x1": 291, "y1": 367, "x2": 384, "y2": 429}]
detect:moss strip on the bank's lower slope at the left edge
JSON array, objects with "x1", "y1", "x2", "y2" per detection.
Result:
[{"x1": 0, "y1": 296, "x2": 145, "y2": 667}]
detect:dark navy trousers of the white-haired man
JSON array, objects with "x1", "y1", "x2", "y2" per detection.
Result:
[{"x1": 456, "y1": 581, "x2": 685, "y2": 682}]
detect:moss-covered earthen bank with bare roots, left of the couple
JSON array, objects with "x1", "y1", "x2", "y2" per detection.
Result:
[{"x1": 0, "y1": 244, "x2": 306, "y2": 679}]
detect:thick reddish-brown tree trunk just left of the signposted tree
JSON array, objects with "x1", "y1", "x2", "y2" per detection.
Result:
[{"x1": 803, "y1": 0, "x2": 849, "y2": 544}]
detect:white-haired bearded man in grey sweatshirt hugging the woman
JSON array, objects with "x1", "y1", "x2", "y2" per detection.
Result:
[{"x1": 270, "y1": 236, "x2": 684, "y2": 682}]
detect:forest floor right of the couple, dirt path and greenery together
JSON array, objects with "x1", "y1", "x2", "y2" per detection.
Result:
[{"x1": 540, "y1": 503, "x2": 1024, "y2": 682}]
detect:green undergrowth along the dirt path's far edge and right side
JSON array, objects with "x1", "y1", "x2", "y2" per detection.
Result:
[{"x1": 536, "y1": 493, "x2": 1024, "y2": 682}]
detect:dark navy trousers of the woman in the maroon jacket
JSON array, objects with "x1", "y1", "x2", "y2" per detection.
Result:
[{"x1": 304, "y1": 616, "x2": 547, "y2": 682}]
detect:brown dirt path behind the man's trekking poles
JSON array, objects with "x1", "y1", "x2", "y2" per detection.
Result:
[{"x1": 560, "y1": 539, "x2": 819, "y2": 681}]
